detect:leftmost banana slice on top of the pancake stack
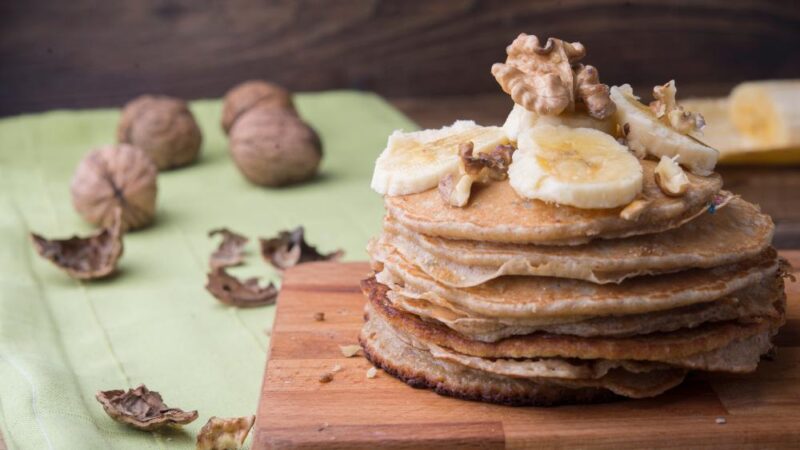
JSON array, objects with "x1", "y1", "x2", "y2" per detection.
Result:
[{"x1": 371, "y1": 120, "x2": 509, "y2": 196}]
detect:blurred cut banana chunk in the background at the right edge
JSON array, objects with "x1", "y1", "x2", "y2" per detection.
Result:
[{"x1": 729, "y1": 80, "x2": 800, "y2": 148}]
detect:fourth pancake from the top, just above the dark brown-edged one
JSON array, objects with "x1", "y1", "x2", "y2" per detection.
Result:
[{"x1": 386, "y1": 277, "x2": 783, "y2": 342}]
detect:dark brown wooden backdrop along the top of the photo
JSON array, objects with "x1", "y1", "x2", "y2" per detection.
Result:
[{"x1": 0, "y1": 0, "x2": 800, "y2": 115}]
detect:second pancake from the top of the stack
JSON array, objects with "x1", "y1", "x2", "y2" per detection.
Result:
[{"x1": 380, "y1": 198, "x2": 775, "y2": 287}]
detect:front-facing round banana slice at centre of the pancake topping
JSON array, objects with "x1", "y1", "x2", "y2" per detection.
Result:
[{"x1": 508, "y1": 125, "x2": 642, "y2": 209}]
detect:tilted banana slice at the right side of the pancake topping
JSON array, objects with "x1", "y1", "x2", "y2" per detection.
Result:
[{"x1": 611, "y1": 84, "x2": 719, "y2": 175}]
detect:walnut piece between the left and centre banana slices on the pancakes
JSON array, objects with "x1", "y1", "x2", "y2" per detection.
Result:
[{"x1": 438, "y1": 141, "x2": 516, "y2": 208}]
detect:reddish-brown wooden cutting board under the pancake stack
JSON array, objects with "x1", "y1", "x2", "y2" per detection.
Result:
[{"x1": 252, "y1": 251, "x2": 800, "y2": 450}]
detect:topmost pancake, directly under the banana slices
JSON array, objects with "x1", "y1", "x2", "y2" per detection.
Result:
[{"x1": 384, "y1": 161, "x2": 730, "y2": 245}]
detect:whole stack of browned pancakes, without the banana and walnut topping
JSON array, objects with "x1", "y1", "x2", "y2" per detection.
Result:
[{"x1": 360, "y1": 160, "x2": 785, "y2": 405}]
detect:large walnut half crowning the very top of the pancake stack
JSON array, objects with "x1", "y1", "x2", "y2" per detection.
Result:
[{"x1": 492, "y1": 33, "x2": 615, "y2": 119}]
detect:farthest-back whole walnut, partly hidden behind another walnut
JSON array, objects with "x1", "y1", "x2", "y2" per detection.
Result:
[{"x1": 222, "y1": 80, "x2": 294, "y2": 134}]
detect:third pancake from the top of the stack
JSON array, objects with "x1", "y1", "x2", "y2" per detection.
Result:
[{"x1": 372, "y1": 241, "x2": 779, "y2": 321}]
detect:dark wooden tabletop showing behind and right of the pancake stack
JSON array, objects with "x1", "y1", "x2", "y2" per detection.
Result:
[{"x1": 392, "y1": 93, "x2": 800, "y2": 249}]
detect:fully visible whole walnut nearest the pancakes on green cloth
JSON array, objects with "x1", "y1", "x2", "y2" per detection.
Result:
[{"x1": 230, "y1": 108, "x2": 322, "y2": 186}]
